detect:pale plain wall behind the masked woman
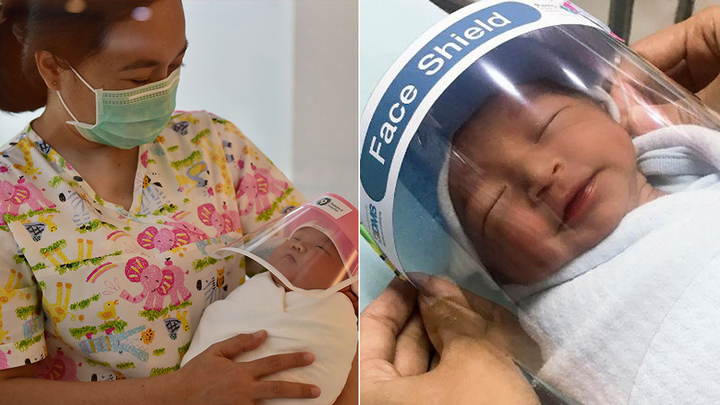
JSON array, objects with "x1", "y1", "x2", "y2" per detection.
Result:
[{"x1": 0, "y1": 0, "x2": 358, "y2": 202}]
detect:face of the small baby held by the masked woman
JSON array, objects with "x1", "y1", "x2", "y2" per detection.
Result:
[{"x1": 269, "y1": 228, "x2": 345, "y2": 290}]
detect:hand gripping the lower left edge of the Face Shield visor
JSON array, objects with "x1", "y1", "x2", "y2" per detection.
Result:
[{"x1": 360, "y1": 279, "x2": 538, "y2": 404}]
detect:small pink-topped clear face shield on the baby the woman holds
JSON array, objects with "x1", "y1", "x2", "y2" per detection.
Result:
[{"x1": 216, "y1": 194, "x2": 358, "y2": 298}]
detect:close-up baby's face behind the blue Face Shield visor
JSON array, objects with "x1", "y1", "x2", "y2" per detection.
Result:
[{"x1": 449, "y1": 88, "x2": 642, "y2": 284}]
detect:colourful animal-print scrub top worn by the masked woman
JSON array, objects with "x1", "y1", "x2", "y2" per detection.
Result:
[{"x1": 0, "y1": 111, "x2": 304, "y2": 381}]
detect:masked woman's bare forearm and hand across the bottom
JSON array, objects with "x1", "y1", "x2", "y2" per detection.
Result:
[{"x1": 0, "y1": 331, "x2": 320, "y2": 404}]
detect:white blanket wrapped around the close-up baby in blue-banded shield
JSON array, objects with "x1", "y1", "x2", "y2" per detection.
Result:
[{"x1": 506, "y1": 126, "x2": 720, "y2": 404}]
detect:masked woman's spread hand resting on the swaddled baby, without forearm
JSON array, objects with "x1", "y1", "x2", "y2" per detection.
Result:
[{"x1": 173, "y1": 331, "x2": 320, "y2": 404}]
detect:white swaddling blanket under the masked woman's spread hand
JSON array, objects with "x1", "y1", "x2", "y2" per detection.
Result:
[{"x1": 182, "y1": 272, "x2": 358, "y2": 405}]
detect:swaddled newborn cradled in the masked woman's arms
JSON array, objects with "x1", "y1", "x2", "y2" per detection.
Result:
[{"x1": 182, "y1": 225, "x2": 358, "y2": 404}]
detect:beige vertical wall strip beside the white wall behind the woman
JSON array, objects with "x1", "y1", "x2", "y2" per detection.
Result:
[{"x1": 292, "y1": 0, "x2": 359, "y2": 205}]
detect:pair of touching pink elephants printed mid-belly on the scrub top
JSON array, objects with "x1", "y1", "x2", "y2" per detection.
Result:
[{"x1": 120, "y1": 256, "x2": 192, "y2": 311}]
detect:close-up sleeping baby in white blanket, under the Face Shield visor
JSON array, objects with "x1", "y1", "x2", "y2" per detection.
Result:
[{"x1": 439, "y1": 79, "x2": 720, "y2": 404}]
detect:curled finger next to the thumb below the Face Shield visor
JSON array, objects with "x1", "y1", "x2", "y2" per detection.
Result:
[{"x1": 393, "y1": 310, "x2": 430, "y2": 377}]
